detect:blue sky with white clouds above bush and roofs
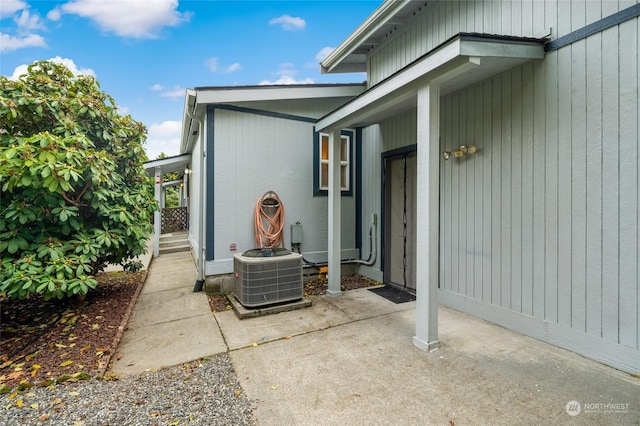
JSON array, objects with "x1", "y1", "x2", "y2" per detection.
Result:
[{"x1": 0, "y1": 0, "x2": 381, "y2": 159}]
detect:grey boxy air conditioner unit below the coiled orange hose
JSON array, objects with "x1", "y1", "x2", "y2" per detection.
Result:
[{"x1": 233, "y1": 248, "x2": 304, "y2": 307}]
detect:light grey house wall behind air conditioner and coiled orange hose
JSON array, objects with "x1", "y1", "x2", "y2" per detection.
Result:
[{"x1": 207, "y1": 106, "x2": 359, "y2": 275}]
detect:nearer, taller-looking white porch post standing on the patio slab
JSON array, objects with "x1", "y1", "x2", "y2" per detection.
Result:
[{"x1": 413, "y1": 82, "x2": 440, "y2": 351}]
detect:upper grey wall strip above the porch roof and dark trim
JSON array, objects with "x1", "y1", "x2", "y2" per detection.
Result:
[{"x1": 367, "y1": 0, "x2": 637, "y2": 86}]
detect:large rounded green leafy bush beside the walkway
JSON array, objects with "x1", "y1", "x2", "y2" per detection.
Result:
[{"x1": 0, "y1": 61, "x2": 156, "y2": 299}]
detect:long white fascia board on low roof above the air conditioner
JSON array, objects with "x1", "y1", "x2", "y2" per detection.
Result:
[{"x1": 197, "y1": 84, "x2": 365, "y2": 105}]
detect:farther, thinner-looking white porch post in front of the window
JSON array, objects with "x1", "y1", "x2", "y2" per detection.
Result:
[{"x1": 327, "y1": 129, "x2": 342, "y2": 296}]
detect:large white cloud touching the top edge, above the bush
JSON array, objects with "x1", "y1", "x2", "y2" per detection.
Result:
[{"x1": 60, "y1": 0, "x2": 191, "y2": 38}]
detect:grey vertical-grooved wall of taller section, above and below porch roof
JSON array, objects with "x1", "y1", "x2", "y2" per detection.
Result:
[{"x1": 363, "y1": 1, "x2": 640, "y2": 374}]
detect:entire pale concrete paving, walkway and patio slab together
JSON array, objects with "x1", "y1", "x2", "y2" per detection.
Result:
[{"x1": 113, "y1": 253, "x2": 640, "y2": 425}]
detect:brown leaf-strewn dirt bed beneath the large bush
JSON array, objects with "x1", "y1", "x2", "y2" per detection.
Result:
[{"x1": 0, "y1": 271, "x2": 147, "y2": 393}]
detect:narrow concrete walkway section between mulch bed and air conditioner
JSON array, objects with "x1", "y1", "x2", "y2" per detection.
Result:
[{"x1": 111, "y1": 252, "x2": 227, "y2": 376}]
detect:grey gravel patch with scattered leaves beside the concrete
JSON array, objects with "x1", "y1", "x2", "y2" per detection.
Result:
[{"x1": 0, "y1": 354, "x2": 256, "y2": 426}]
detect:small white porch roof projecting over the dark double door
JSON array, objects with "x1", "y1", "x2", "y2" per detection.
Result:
[{"x1": 316, "y1": 33, "x2": 544, "y2": 130}]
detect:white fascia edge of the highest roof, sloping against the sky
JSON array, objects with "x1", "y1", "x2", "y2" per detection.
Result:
[{"x1": 320, "y1": 0, "x2": 410, "y2": 74}]
